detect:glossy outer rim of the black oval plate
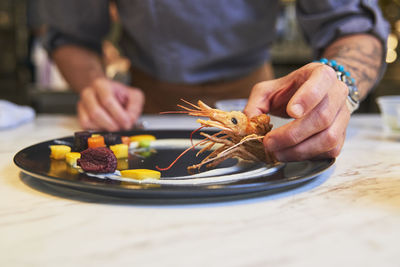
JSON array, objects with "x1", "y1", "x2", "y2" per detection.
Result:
[{"x1": 13, "y1": 129, "x2": 335, "y2": 198}]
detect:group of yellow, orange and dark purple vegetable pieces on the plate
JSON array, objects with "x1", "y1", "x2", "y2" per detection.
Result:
[{"x1": 49, "y1": 131, "x2": 161, "y2": 182}]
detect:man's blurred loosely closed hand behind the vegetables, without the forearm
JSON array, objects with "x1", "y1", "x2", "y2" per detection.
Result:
[{"x1": 77, "y1": 78, "x2": 144, "y2": 131}]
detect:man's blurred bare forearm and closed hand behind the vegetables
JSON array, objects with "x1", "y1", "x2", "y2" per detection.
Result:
[{"x1": 52, "y1": 45, "x2": 144, "y2": 131}]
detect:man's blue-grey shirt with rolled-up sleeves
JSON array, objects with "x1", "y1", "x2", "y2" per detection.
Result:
[{"x1": 44, "y1": 0, "x2": 388, "y2": 83}]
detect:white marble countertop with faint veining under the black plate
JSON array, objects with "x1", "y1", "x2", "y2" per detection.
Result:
[{"x1": 0, "y1": 115, "x2": 400, "y2": 267}]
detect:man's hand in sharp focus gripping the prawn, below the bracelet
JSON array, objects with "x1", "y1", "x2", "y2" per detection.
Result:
[{"x1": 244, "y1": 63, "x2": 350, "y2": 161}]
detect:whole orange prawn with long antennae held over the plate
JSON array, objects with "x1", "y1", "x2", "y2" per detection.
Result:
[{"x1": 158, "y1": 99, "x2": 277, "y2": 173}]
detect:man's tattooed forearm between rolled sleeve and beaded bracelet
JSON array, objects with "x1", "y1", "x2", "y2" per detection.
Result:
[{"x1": 323, "y1": 34, "x2": 383, "y2": 97}]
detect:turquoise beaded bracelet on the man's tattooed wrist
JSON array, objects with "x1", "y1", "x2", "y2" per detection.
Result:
[{"x1": 316, "y1": 58, "x2": 360, "y2": 113}]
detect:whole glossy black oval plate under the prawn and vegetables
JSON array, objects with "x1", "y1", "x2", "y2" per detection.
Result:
[{"x1": 14, "y1": 130, "x2": 335, "y2": 199}]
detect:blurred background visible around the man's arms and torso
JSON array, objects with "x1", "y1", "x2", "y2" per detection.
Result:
[{"x1": 0, "y1": 0, "x2": 400, "y2": 113}]
